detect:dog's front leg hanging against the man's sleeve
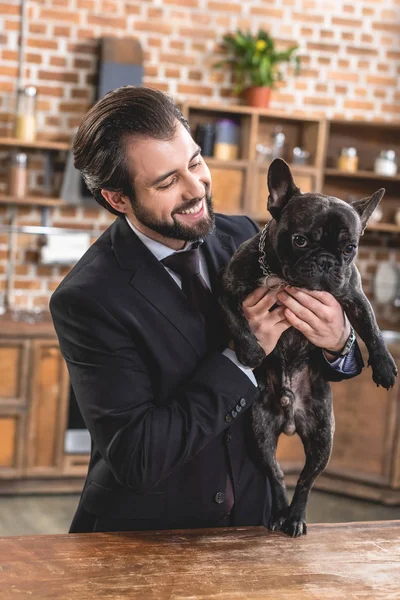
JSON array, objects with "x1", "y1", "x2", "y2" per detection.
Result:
[{"x1": 219, "y1": 296, "x2": 265, "y2": 369}]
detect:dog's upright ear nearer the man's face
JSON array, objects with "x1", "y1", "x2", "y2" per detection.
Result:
[{"x1": 268, "y1": 158, "x2": 300, "y2": 221}]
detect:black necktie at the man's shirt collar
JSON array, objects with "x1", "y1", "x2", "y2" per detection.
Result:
[{"x1": 161, "y1": 248, "x2": 214, "y2": 320}]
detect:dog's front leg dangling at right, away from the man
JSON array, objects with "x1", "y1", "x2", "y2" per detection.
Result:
[{"x1": 341, "y1": 290, "x2": 397, "y2": 390}]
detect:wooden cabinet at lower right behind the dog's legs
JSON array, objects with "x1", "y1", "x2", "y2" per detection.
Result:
[{"x1": 278, "y1": 345, "x2": 400, "y2": 504}]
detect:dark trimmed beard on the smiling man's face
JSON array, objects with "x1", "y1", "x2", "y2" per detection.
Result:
[{"x1": 131, "y1": 191, "x2": 215, "y2": 242}]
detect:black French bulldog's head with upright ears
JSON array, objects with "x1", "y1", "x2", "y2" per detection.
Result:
[{"x1": 268, "y1": 159, "x2": 385, "y2": 293}]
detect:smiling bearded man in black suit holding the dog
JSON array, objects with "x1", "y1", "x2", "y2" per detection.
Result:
[{"x1": 50, "y1": 86, "x2": 360, "y2": 532}]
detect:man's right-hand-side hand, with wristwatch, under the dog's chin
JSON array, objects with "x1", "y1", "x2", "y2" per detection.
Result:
[{"x1": 277, "y1": 286, "x2": 350, "y2": 359}]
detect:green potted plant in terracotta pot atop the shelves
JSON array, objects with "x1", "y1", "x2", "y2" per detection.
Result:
[{"x1": 214, "y1": 29, "x2": 300, "y2": 107}]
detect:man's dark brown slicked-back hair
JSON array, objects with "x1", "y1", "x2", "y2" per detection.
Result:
[{"x1": 72, "y1": 85, "x2": 190, "y2": 215}]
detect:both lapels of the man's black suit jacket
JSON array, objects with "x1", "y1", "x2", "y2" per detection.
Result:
[{"x1": 111, "y1": 218, "x2": 233, "y2": 356}]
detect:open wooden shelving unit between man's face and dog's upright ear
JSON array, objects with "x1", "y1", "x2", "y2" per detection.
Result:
[{"x1": 181, "y1": 103, "x2": 326, "y2": 220}]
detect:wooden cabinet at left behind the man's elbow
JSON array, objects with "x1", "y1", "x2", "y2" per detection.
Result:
[{"x1": 0, "y1": 318, "x2": 88, "y2": 493}]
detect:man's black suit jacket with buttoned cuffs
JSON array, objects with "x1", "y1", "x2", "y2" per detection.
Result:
[{"x1": 50, "y1": 215, "x2": 360, "y2": 532}]
